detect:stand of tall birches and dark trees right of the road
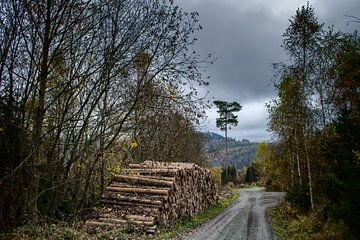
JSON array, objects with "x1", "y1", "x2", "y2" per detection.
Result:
[{"x1": 253, "y1": 4, "x2": 360, "y2": 239}]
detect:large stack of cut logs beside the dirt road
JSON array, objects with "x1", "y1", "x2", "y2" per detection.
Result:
[{"x1": 86, "y1": 161, "x2": 218, "y2": 232}]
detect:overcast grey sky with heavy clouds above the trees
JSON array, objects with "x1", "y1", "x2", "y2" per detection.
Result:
[{"x1": 175, "y1": 0, "x2": 360, "y2": 141}]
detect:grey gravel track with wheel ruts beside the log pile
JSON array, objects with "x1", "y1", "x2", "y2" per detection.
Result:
[{"x1": 185, "y1": 188, "x2": 283, "y2": 240}]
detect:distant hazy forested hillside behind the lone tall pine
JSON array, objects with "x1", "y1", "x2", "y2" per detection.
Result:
[{"x1": 202, "y1": 132, "x2": 258, "y2": 170}]
